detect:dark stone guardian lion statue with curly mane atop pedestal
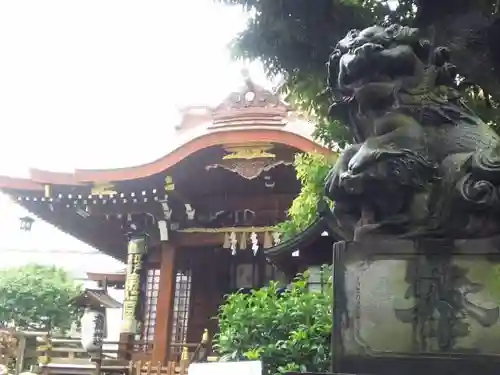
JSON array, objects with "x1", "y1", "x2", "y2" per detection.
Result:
[{"x1": 325, "y1": 25, "x2": 500, "y2": 239}]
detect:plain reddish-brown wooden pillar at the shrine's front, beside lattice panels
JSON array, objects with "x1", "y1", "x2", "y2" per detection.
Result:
[{"x1": 152, "y1": 242, "x2": 176, "y2": 364}]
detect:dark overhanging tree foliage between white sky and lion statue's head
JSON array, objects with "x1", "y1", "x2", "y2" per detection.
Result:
[{"x1": 222, "y1": 0, "x2": 388, "y2": 145}]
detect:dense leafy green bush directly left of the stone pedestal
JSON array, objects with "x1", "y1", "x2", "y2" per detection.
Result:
[{"x1": 214, "y1": 268, "x2": 333, "y2": 375}]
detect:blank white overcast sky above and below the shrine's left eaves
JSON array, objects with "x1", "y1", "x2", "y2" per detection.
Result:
[{"x1": 0, "y1": 0, "x2": 267, "y2": 268}]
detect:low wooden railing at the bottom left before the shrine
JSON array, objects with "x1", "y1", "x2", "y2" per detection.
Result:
[{"x1": 4, "y1": 331, "x2": 217, "y2": 375}]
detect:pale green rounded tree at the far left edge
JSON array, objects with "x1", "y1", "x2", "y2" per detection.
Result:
[{"x1": 0, "y1": 264, "x2": 81, "y2": 332}]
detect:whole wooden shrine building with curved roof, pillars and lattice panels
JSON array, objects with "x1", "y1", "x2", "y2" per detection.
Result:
[{"x1": 0, "y1": 80, "x2": 338, "y2": 363}]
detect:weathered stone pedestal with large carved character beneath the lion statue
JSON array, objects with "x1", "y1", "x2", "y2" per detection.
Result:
[{"x1": 333, "y1": 237, "x2": 500, "y2": 375}]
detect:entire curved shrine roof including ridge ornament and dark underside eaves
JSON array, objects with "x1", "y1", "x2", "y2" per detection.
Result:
[{"x1": 0, "y1": 80, "x2": 333, "y2": 260}]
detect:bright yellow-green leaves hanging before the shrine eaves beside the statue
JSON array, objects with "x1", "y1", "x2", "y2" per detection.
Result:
[{"x1": 279, "y1": 154, "x2": 332, "y2": 239}]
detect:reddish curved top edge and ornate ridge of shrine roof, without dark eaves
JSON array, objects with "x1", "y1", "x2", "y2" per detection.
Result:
[{"x1": 0, "y1": 80, "x2": 331, "y2": 191}]
